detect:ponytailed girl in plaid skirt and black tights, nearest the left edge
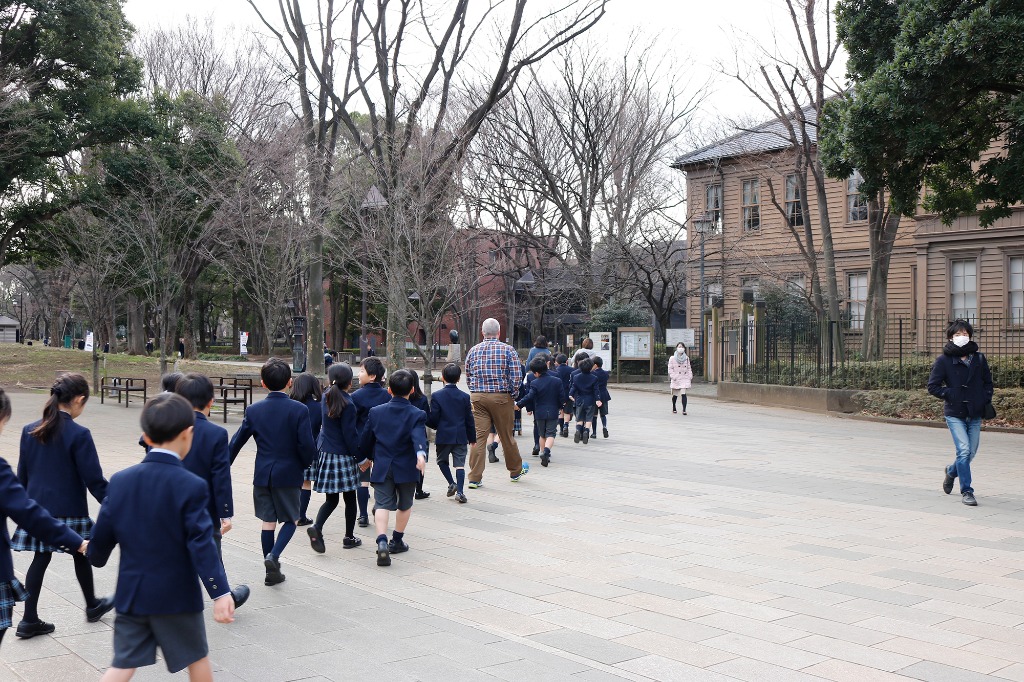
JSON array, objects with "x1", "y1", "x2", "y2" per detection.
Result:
[{"x1": 11, "y1": 374, "x2": 114, "y2": 639}]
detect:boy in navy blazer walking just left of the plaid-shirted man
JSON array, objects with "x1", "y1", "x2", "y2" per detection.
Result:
[{"x1": 427, "y1": 363, "x2": 476, "y2": 504}]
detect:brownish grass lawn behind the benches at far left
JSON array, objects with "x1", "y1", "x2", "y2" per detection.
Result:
[{"x1": 0, "y1": 343, "x2": 260, "y2": 394}]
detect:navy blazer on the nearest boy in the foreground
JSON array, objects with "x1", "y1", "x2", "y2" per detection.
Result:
[{"x1": 88, "y1": 450, "x2": 231, "y2": 615}]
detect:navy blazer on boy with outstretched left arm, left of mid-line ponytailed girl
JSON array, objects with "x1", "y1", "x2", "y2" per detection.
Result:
[{"x1": 229, "y1": 391, "x2": 316, "y2": 487}]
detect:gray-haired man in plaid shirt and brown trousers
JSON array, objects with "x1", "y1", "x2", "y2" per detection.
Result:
[{"x1": 466, "y1": 317, "x2": 529, "y2": 487}]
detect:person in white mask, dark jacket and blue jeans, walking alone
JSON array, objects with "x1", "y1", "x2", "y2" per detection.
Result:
[{"x1": 928, "y1": 319, "x2": 992, "y2": 507}]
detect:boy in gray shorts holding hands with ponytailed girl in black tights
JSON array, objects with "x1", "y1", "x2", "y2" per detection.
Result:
[{"x1": 359, "y1": 370, "x2": 427, "y2": 566}]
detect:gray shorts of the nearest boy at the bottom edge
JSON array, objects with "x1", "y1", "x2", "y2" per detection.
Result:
[{"x1": 111, "y1": 611, "x2": 210, "y2": 673}]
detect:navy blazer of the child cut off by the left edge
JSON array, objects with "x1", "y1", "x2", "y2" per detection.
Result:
[{"x1": 0, "y1": 459, "x2": 83, "y2": 583}]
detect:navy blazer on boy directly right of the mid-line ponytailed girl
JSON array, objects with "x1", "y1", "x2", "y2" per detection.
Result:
[{"x1": 359, "y1": 397, "x2": 427, "y2": 483}]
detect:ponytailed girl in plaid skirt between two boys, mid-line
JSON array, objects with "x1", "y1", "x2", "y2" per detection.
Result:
[{"x1": 306, "y1": 363, "x2": 362, "y2": 554}]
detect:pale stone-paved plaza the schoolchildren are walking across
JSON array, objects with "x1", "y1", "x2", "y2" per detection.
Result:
[{"x1": 0, "y1": 387, "x2": 1024, "y2": 682}]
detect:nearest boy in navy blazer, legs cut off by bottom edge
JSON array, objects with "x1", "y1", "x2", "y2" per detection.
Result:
[{"x1": 88, "y1": 393, "x2": 234, "y2": 682}]
